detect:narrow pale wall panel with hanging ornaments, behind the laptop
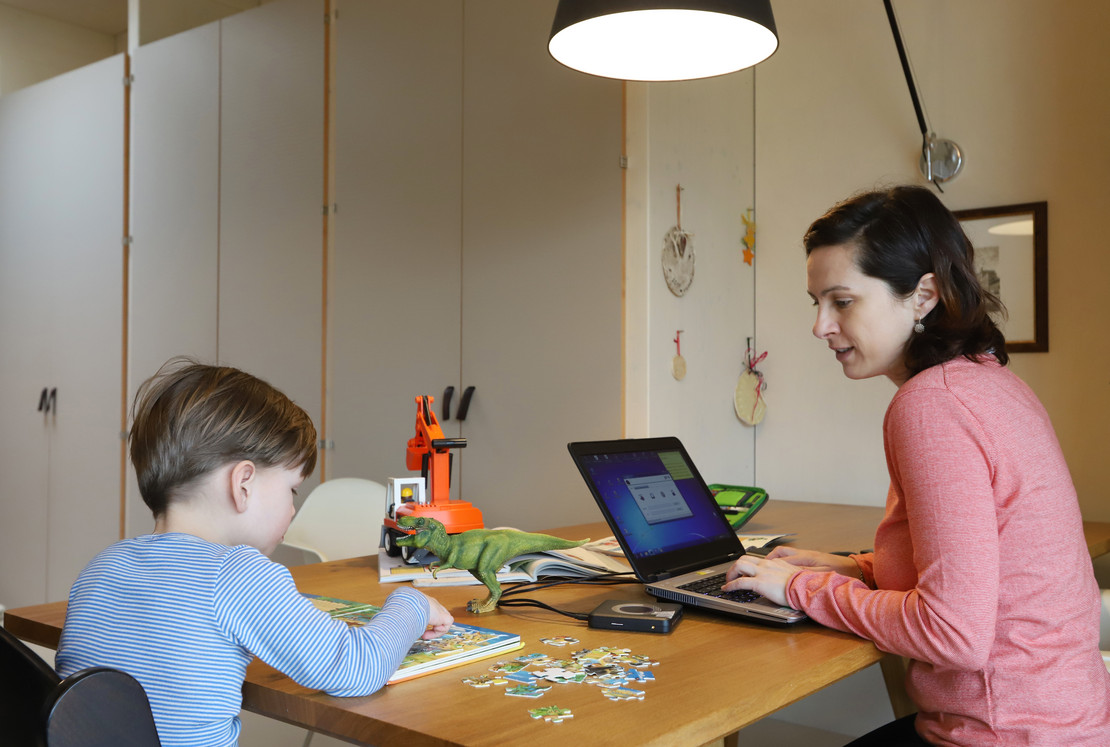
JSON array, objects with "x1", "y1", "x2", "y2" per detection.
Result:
[{"x1": 624, "y1": 70, "x2": 756, "y2": 484}]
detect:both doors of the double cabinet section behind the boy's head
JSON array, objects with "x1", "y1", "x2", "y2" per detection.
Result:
[{"x1": 128, "y1": 0, "x2": 324, "y2": 535}]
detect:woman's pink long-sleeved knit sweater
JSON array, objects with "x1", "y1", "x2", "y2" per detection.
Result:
[{"x1": 787, "y1": 357, "x2": 1110, "y2": 747}]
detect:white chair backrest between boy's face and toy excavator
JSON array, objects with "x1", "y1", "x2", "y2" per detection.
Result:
[{"x1": 282, "y1": 477, "x2": 385, "y2": 563}]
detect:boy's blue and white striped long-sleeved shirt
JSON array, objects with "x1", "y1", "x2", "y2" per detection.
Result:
[{"x1": 57, "y1": 534, "x2": 428, "y2": 747}]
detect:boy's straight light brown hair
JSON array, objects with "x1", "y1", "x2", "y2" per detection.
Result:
[{"x1": 130, "y1": 357, "x2": 316, "y2": 517}]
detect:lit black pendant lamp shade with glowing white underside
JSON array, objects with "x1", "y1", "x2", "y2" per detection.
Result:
[{"x1": 547, "y1": 0, "x2": 778, "y2": 81}]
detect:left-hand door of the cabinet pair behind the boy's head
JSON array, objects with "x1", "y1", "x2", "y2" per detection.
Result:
[{"x1": 127, "y1": 22, "x2": 220, "y2": 536}]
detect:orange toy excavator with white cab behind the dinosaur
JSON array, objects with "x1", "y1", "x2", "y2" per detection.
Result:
[{"x1": 382, "y1": 395, "x2": 483, "y2": 561}]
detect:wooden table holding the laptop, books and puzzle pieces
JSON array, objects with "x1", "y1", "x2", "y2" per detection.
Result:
[{"x1": 4, "y1": 502, "x2": 1110, "y2": 746}]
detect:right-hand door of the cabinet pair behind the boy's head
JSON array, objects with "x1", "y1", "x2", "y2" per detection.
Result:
[{"x1": 218, "y1": 0, "x2": 325, "y2": 495}]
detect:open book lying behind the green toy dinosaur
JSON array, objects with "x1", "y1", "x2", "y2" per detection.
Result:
[{"x1": 377, "y1": 547, "x2": 632, "y2": 586}]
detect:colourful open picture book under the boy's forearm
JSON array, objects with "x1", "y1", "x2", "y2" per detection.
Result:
[{"x1": 304, "y1": 594, "x2": 524, "y2": 685}]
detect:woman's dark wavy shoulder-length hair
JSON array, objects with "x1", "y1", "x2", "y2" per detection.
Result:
[{"x1": 805, "y1": 186, "x2": 1009, "y2": 376}]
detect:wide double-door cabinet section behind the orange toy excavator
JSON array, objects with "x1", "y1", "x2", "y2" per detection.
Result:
[{"x1": 327, "y1": 0, "x2": 622, "y2": 528}]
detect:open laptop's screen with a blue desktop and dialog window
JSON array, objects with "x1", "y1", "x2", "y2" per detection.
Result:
[{"x1": 569, "y1": 437, "x2": 744, "y2": 576}]
